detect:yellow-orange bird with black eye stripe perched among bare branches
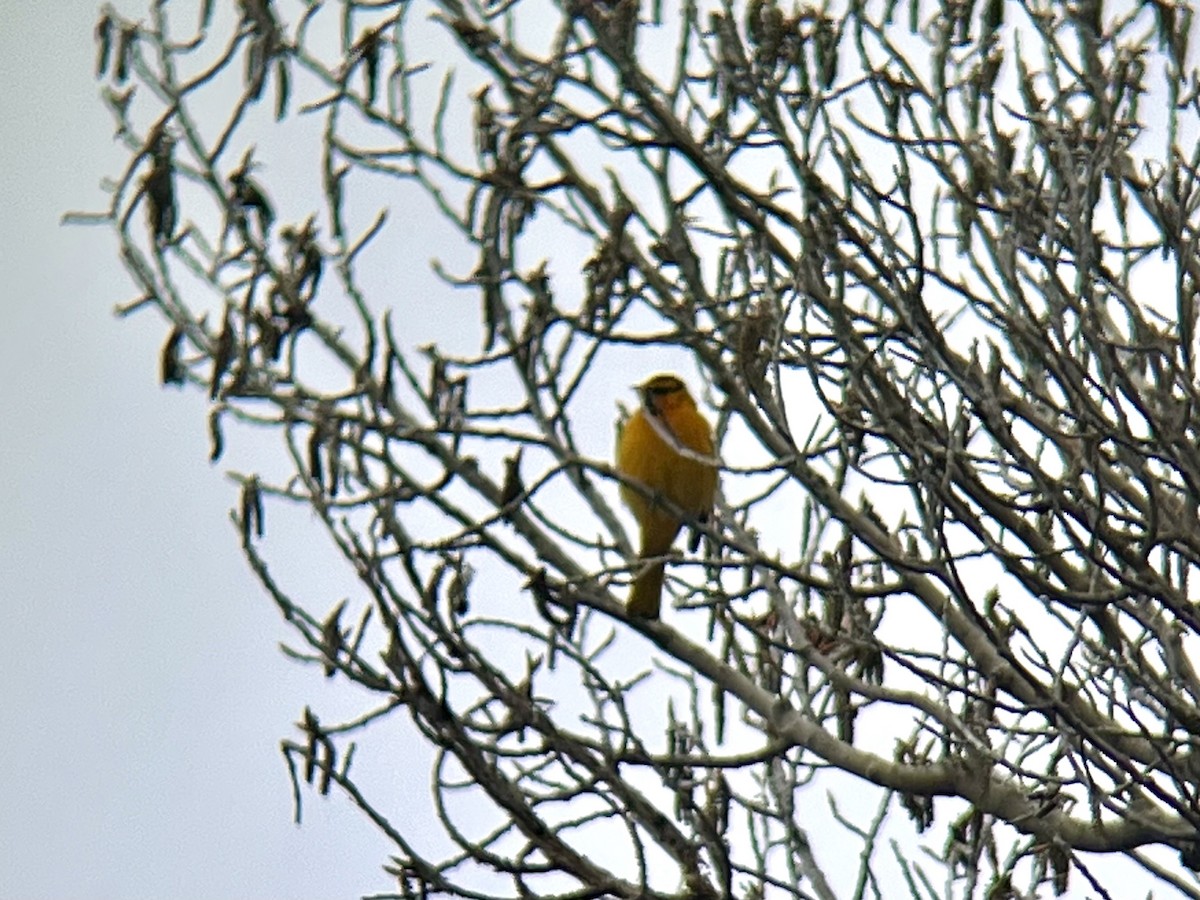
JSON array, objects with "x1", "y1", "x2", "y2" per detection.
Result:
[{"x1": 617, "y1": 374, "x2": 718, "y2": 619}]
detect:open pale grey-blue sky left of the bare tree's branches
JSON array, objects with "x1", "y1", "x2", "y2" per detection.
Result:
[{"x1": 0, "y1": 0, "x2": 403, "y2": 900}]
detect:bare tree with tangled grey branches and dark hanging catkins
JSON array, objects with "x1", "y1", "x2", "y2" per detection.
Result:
[{"x1": 77, "y1": 0, "x2": 1200, "y2": 899}]
